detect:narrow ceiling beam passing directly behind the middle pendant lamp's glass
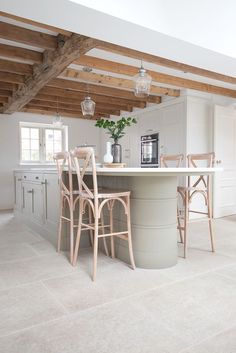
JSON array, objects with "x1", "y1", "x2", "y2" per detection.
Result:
[{"x1": 29, "y1": 98, "x2": 133, "y2": 112}]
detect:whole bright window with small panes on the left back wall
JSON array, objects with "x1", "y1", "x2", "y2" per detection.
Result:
[{"x1": 20, "y1": 123, "x2": 67, "y2": 164}]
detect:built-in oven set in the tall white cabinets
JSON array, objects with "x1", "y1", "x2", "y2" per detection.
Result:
[{"x1": 141, "y1": 133, "x2": 159, "y2": 168}]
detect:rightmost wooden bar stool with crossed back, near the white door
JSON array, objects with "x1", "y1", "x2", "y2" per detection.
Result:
[{"x1": 178, "y1": 152, "x2": 215, "y2": 258}]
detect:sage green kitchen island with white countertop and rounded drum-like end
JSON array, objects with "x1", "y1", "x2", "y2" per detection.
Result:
[{"x1": 14, "y1": 168, "x2": 219, "y2": 269}]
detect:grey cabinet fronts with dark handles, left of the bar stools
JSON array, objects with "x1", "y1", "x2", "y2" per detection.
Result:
[{"x1": 14, "y1": 170, "x2": 60, "y2": 244}]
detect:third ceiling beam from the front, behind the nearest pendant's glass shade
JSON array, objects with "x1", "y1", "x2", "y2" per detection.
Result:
[{"x1": 60, "y1": 69, "x2": 180, "y2": 97}]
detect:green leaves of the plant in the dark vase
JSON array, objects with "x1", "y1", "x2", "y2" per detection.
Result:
[{"x1": 95, "y1": 117, "x2": 137, "y2": 143}]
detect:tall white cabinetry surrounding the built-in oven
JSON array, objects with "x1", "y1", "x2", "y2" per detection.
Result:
[{"x1": 115, "y1": 97, "x2": 186, "y2": 167}]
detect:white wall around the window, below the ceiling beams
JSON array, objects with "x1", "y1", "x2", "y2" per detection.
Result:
[{"x1": 0, "y1": 113, "x2": 100, "y2": 209}]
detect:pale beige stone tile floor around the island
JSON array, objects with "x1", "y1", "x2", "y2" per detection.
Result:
[{"x1": 0, "y1": 212, "x2": 236, "y2": 353}]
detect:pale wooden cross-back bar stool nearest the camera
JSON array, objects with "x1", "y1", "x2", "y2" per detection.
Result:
[{"x1": 71, "y1": 147, "x2": 135, "y2": 280}]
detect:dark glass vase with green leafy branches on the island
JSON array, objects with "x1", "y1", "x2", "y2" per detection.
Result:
[{"x1": 95, "y1": 117, "x2": 137, "y2": 163}]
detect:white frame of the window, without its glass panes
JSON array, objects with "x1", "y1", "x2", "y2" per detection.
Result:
[{"x1": 19, "y1": 121, "x2": 68, "y2": 165}]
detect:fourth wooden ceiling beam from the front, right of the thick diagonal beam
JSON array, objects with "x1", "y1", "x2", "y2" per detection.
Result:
[{"x1": 47, "y1": 78, "x2": 160, "y2": 103}]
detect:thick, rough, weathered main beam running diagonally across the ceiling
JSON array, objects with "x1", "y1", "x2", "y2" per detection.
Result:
[{"x1": 0, "y1": 34, "x2": 96, "y2": 113}]
